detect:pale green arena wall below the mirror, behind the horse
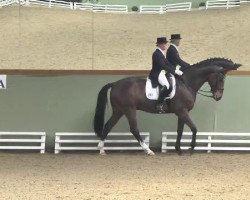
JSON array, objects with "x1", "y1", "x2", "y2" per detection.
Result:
[{"x1": 0, "y1": 74, "x2": 250, "y2": 151}]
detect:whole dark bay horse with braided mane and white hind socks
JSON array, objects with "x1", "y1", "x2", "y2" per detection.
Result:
[{"x1": 94, "y1": 58, "x2": 241, "y2": 155}]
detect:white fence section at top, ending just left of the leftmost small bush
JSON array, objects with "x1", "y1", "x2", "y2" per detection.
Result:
[{"x1": 93, "y1": 4, "x2": 128, "y2": 13}]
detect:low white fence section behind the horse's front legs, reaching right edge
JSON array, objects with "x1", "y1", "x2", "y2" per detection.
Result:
[{"x1": 162, "y1": 132, "x2": 250, "y2": 153}]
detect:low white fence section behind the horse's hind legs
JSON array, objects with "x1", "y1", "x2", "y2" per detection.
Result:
[{"x1": 55, "y1": 132, "x2": 150, "y2": 154}]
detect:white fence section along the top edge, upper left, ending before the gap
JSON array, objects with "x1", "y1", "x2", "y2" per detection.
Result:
[{"x1": 25, "y1": 0, "x2": 74, "y2": 9}]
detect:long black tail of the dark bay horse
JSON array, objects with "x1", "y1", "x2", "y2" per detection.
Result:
[{"x1": 94, "y1": 83, "x2": 113, "y2": 138}]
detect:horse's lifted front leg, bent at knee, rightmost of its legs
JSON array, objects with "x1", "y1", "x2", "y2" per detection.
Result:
[{"x1": 177, "y1": 110, "x2": 197, "y2": 151}]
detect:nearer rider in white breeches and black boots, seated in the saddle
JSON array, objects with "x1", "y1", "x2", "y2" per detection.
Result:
[{"x1": 149, "y1": 37, "x2": 183, "y2": 113}]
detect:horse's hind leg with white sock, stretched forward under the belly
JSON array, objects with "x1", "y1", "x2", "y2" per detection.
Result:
[{"x1": 125, "y1": 108, "x2": 155, "y2": 155}]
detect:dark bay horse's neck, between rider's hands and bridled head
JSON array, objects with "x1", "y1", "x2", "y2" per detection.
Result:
[{"x1": 184, "y1": 67, "x2": 214, "y2": 93}]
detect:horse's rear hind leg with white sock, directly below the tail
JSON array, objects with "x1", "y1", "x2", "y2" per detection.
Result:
[{"x1": 98, "y1": 111, "x2": 123, "y2": 155}]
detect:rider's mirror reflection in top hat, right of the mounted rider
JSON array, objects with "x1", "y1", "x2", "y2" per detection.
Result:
[{"x1": 166, "y1": 34, "x2": 190, "y2": 70}]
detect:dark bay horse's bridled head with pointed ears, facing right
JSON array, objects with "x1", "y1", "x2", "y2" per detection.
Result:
[{"x1": 208, "y1": 59, "x2": 241, "y2": 101}]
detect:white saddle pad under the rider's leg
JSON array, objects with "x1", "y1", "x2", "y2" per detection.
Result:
[{"x1": 145, "y1": 74, "x2": 176, "y2": 100}]
